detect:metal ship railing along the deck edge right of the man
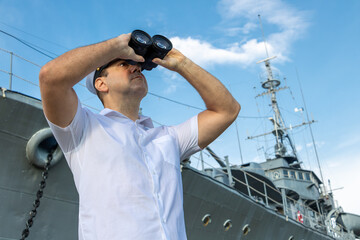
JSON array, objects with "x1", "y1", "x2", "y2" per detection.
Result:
[{"x1": 192, "y1": 155, "x2": 344, "y2": 238}]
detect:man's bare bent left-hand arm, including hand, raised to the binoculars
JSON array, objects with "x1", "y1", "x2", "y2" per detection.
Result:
[{"x1": 39, "y1": 33, "x2": 144, "y2": 127}]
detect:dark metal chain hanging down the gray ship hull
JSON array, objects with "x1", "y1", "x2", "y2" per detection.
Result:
[{"x1": 20, "y1": 151, "x2": 53, "y2": 240}]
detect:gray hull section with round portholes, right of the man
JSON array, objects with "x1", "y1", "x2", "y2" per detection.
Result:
[{"x1": 182, "y1": 167, "x2": 333, "y2": 240}]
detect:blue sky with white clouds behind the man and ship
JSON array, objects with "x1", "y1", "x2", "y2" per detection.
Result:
[{"x1": 0, "y1": 0, "x2": 360, "y2": 214}]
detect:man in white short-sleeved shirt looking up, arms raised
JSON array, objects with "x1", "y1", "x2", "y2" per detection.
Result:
[{"x1": 39, "y1": 34, "x2": 240, "y2": 240}]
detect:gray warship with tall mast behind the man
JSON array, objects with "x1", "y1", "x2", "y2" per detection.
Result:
[{"x1": 0, "y1": 40, "x2": 360, "y2": 240}]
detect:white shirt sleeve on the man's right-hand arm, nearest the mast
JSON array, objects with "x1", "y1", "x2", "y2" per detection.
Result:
[{"x1": 170, "y1": 115, "x2": 201, "y2": 160}]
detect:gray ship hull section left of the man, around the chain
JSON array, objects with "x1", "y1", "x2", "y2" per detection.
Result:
[{"x1": 0, "y1": 91, "x2": 78, "y2": 240}]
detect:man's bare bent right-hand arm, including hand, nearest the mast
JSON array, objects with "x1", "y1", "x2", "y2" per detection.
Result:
[{"x1": 154, "y1": 49, "x2": 240, "y2": 148}]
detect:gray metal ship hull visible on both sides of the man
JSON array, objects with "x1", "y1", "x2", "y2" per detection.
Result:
[{"x1": 0, "y1": 91, "x2": 340, "y2": 240}]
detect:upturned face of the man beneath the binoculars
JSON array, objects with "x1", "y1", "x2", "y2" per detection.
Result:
[{"x1": 100, "y1": 60, "x2": 148, "y2": 99}]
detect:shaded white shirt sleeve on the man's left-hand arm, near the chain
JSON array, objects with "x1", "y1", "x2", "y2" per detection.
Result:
[{"x1": 45, "y1": 99, "x2": 86, "y2": 153}]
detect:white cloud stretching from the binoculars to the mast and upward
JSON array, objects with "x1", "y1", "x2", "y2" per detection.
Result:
[{"x1": 171, "y1": 0, "x2": 308, "y2": 67}]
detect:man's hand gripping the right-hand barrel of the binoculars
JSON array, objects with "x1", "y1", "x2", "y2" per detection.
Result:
[{"x1": 153, "y1": 48, "x2": 188, "y2": 72}]
